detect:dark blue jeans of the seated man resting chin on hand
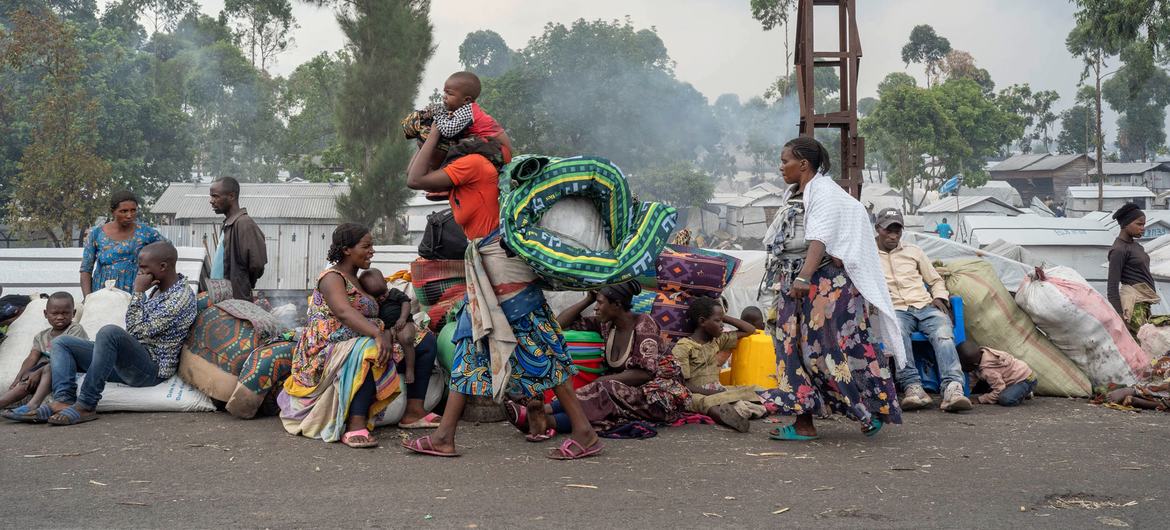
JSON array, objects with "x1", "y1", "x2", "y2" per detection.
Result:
[{"x1": 50, "y1": 325, "x2": 163, "y2": 409}]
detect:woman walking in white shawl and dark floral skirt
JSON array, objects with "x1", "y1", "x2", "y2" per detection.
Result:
[{"x1": 763, "y1": 137, "x2": 906, "y2": 441}]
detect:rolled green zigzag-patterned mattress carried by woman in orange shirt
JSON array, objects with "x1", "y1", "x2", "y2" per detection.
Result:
[{"x1": 500, "y1": 156, "x2": 677, "y2": 290}]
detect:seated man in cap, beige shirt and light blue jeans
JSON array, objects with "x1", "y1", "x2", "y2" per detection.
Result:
[{"x1": 876, "y1": 208, "x2": 971, "y2": 412}]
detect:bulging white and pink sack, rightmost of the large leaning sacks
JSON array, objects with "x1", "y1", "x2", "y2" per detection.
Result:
[{"x1": 1016, "y1": 267, "x2": 1150, "y2": 387}]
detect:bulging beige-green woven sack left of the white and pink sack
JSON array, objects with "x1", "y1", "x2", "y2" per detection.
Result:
[{"x1": 938, "y1": 257, "x2": 1092, "y2": 398}]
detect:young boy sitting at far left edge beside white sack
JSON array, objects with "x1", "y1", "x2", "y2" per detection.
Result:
[{"x1": 0, "y1": 292, "x2": 89, "y2": 421}]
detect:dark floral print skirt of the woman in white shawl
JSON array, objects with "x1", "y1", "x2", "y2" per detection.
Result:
[{"x1": 761, "y1": 264, "x2": 902, "y2": 424}]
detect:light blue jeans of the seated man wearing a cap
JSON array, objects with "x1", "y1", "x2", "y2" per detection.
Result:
[{"x1": 896, "y1": 305, "x2": 963, "y2": 391}]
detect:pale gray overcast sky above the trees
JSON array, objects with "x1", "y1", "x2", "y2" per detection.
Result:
[{"x1": 202, "y1": 0, "x2": 1116, "y2": 144}]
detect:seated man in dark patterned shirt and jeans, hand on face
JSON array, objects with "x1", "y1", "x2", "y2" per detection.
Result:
[{"x1": 29, "y1": 241, "x2": 195, "y2": 425}]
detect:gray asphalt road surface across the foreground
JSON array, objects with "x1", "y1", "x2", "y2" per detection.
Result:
[{"x1": 0, "y1": 399, "x2": 1170, "y2": 529}]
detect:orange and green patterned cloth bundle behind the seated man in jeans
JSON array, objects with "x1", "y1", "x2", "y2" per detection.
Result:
[{"x1": 179, "y1": 295, "x2": 296, "y2": 419}]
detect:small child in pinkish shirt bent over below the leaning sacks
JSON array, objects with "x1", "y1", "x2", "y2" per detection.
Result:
[{"x1": 958, "y1": 339, "x2": 1035, "y2": 407}]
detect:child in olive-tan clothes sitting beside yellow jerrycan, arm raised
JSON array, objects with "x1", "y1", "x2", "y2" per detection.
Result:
[{"x1": 672, "y1": 297, "x2": 764, "y2": 433}]
